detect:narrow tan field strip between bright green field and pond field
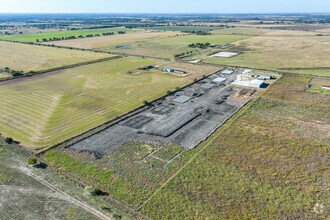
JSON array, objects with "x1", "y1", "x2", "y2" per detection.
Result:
[{"x1": 52, "y1": 31, "x2": 187, "y2": 49}]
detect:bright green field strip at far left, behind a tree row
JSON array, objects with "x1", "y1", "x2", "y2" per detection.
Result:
[{"x1": 0, "y1": 28, "x2": 140, "y2": 44}]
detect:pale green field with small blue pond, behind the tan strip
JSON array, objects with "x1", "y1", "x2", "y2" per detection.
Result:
[{"x1": 102, "y1": 34, "x2": 247, "y2": 58}]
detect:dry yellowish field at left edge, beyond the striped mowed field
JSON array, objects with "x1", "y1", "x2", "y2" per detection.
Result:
[{"x1": 0, "y1": 41, "x2": 114, "y2": 72}]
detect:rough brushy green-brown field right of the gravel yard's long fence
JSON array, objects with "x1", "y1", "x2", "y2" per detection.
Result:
[{"x1": 141, "y1": 76, "x2": 330, "y2": 219}]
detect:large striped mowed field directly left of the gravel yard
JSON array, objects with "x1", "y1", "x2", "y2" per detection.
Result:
[{"x1": 0, "y1": 58, "x2": 219, "y2": 149}]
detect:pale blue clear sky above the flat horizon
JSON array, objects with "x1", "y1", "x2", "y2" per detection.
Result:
[{"x1": 0, "y1": 0, "x2": 330, "y2": 14}]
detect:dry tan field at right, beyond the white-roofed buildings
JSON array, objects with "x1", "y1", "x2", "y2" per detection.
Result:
[{"x1": 204, "y1": 30, "x2": 330, "y2": 76}]
